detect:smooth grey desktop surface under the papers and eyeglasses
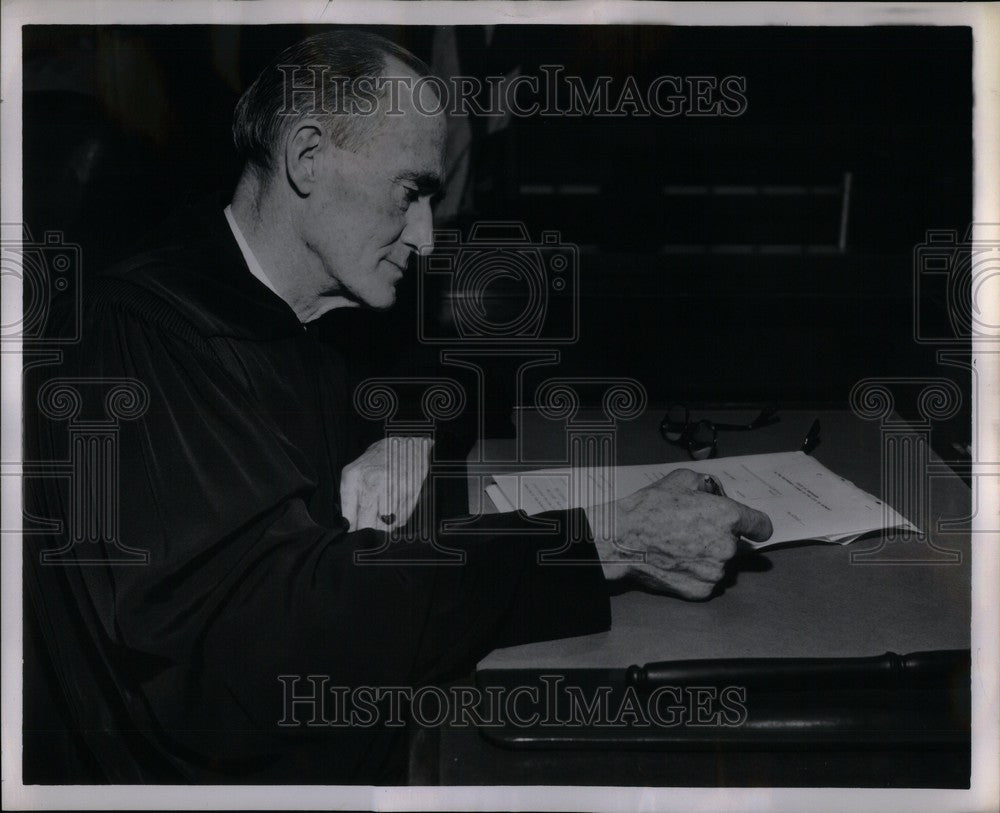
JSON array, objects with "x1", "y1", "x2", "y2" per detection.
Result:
[{"x1": 469, "y1": 410, "x2": 971, "y2": 670}]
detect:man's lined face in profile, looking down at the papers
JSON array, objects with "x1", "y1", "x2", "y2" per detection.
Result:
[{"x1": 301, "y1": 69, "x2": 446, "y2": 309}]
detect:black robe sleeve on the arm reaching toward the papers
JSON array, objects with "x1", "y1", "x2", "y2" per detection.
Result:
[{"x1": 58, "y1": 284, "x2": 610, "y2": 744}]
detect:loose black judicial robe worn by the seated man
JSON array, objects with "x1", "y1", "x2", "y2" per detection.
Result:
[{"x1": 24, "y1": 201, "x2": 610, "y2": 783}]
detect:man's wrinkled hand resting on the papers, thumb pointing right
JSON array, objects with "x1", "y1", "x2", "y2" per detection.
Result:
[{"x1": 586, "y1": 469, "x2": 773, "y2": 599}]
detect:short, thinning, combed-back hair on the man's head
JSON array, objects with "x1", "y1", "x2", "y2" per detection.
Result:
[{"x1": 233, "y1": 30, "x2": 430, "y2": 177}]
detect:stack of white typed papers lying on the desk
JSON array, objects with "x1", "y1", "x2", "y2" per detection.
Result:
[{"x1": 486, "y1": 452, "x2": 917, "y2": 549}]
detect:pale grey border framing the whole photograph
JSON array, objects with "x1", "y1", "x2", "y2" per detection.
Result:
[{"x1": 0, "y1": 0, "x2": 1000, "y2": 813}]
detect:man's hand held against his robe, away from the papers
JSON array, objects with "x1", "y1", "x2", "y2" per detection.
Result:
[{"x1": 340, "y1": 437, "x2": 434, "y2": 531}]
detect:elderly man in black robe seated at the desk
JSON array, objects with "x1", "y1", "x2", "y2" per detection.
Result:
[{"x1": 26, "y1": 32, "x2": 770, "y2": 783}]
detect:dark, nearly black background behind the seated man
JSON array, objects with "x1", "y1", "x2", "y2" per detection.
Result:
[{"x1": 24, "y1": 25, "x2": 972, "y2": 456}]
